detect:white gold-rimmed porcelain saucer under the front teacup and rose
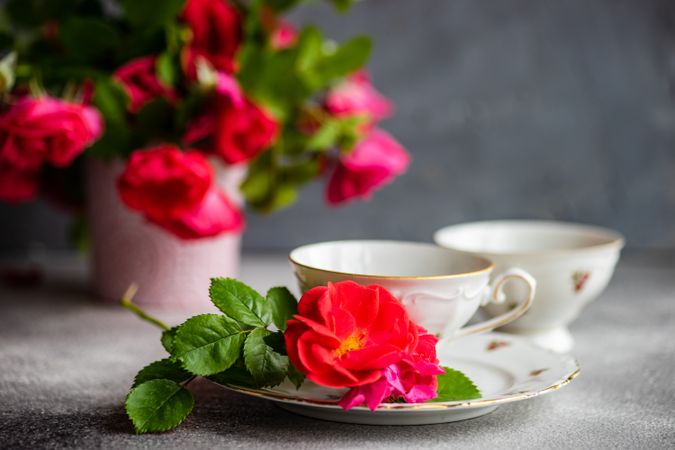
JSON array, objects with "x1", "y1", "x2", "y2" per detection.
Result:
[{"x1": 217, "y1": 332, "x2": 579, "y2": 425}]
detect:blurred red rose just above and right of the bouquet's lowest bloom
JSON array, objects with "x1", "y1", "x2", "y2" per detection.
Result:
[{"x1": 183, "y1": 73, "x2": 279, "y2": 164}]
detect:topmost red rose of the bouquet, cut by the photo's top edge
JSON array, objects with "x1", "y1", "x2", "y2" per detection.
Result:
[{"x1": 182, "y1": 0, "x2": 242, "y2": 78}]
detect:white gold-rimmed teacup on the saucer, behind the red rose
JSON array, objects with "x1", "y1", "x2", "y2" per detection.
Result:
[{"x1": 289, "y1": 240, "x2": 535, "y2": 338}]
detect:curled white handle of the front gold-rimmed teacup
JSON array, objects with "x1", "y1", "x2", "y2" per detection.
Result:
[{"x1": 452, "y1": 267, "x2": 537, "y2": 338}]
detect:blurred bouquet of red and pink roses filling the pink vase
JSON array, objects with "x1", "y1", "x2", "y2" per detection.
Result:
[{"x1": 0, "y1": 0, "x2": 409, "y2": 239}]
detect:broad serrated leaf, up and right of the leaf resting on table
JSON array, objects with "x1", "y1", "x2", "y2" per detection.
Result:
[{"x1": 173, "y1": 314, "x2": 244, "y2": 376}]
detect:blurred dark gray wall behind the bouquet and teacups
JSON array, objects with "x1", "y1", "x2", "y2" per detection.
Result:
[{"x1": 0, "y1": 0, "x2": 675, "y2": 254}]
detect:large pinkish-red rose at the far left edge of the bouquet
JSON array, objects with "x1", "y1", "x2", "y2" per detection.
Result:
[{"x1": 0, "y1": 97, "x2": 103, "y2": 170}]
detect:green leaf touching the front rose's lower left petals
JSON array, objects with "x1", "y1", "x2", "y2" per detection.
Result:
[{"x1": 244, "y1": 328, "x2": 289, "y2": 387}]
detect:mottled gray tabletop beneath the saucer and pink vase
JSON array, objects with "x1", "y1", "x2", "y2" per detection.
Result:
[{"x1": 0, "y1": 254, "x2": 675, "y2": 449}]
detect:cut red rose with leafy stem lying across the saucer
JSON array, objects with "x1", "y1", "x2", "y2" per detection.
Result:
[{"x1": 123, "y1": 278, "x2": 480, "y2": 433}]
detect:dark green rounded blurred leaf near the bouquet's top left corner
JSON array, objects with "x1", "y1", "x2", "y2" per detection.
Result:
[{"x1": 59, "y1": 16, "x2": 123, "y2": 63}]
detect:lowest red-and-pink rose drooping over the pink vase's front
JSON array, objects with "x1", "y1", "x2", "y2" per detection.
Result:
[{"x1": 117, "y1": 145, "x2": 244, "y2": 239}]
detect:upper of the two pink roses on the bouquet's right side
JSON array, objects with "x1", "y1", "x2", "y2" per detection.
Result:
[{"x1": 324, "y1": 71, "x2": 393, "y2": 122}]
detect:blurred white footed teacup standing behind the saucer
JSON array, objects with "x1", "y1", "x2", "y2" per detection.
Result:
[{"x1": 434, "y1": 220, "x2": 624, "y2": 352}]
